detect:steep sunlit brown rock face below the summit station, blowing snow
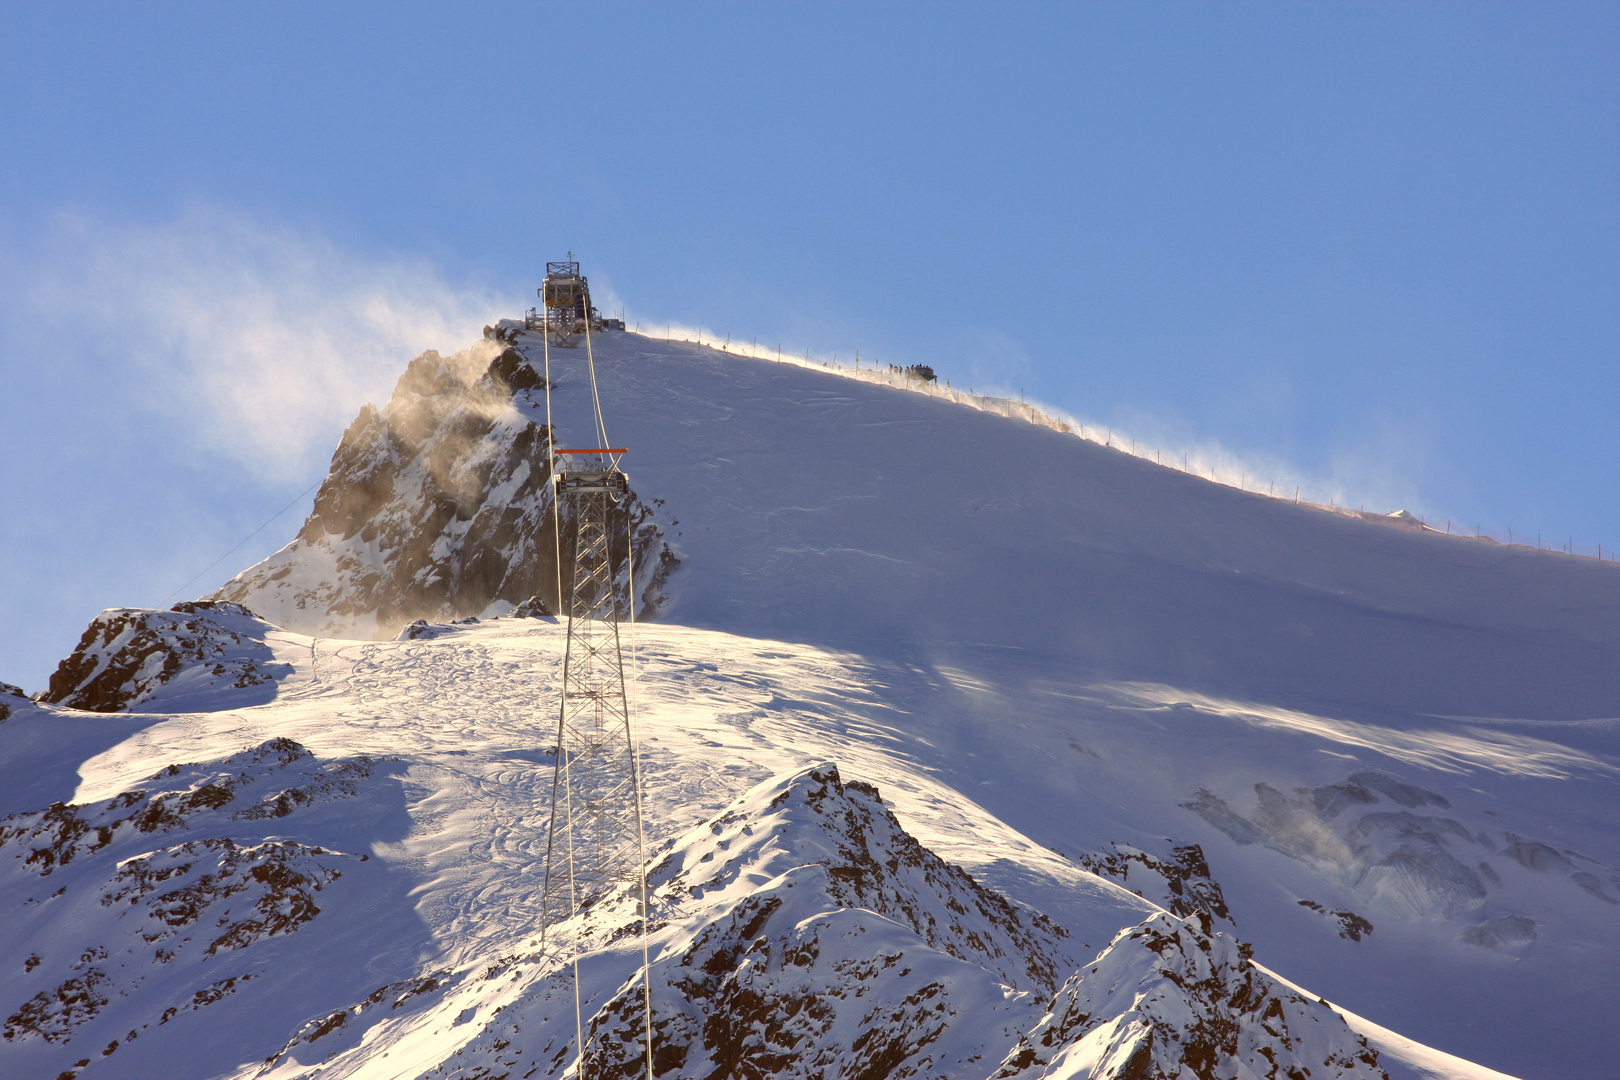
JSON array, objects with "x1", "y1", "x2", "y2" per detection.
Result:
[{"x1": 215, "y1": 338, "x2": 677, "y2": 638}]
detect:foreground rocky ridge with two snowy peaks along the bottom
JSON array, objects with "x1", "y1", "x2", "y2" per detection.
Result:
[{"x1": 285, "y1": 764, "x2": 1383, "y2": 1080}]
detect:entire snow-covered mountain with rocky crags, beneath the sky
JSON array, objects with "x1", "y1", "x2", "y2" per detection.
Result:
[{"x1": 0, "y1": 334, "x2": 1620, "y2": 1080}]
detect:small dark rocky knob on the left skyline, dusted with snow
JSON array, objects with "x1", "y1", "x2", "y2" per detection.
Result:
[{"x1": 39, "y1": 601, "x2": 290, "y2": 712}]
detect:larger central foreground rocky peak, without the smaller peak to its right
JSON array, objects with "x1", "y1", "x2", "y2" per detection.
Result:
[{"x1": 414, "y1": 764, "x2": 1076, "y2": 1080}]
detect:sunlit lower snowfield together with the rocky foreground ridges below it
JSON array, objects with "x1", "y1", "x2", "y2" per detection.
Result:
[{"x1": 0, "y1": 619, "x2": 1401, "y2": 1080}]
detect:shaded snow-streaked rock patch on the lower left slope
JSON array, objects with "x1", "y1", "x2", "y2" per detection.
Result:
[{"x1": 0, "y1": 738, "x2": 376, "y2": 1049}]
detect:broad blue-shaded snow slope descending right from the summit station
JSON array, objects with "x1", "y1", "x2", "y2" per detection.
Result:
[{"x1": 554, "y1": 338, "x2": 1620, "y2": 1075}]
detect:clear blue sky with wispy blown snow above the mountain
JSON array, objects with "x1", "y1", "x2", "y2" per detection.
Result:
[{"x1": 0, "y1": 3, "x2": 1620, "y2": 690}]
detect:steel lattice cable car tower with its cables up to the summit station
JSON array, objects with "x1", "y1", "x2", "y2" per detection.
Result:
[{"x1": 525, "y1": 253, "x2": 653, "y2": 1080}]
